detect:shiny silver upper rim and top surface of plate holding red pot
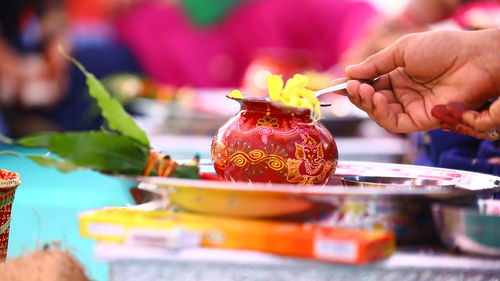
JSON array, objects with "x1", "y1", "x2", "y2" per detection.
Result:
[{"x1": 129, "y1": 160, "x2": 500, "y2": 198}]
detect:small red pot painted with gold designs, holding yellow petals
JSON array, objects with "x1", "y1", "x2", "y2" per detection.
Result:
[{"x1": 211, "y1": 97, "x2": 338, "y2": 185}]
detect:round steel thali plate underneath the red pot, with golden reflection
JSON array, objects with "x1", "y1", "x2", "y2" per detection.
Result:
[{"x1": 135, "y1": 161, "x2": 500, "y2": 242}]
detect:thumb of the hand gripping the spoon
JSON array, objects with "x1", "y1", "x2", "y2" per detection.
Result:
[{"x1": 345, "y1": 35, "x2": 413, "y2": 79}]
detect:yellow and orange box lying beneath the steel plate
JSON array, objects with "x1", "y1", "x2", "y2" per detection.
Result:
[{"x1": 80, "y1": 208, "x2": 395, "y2": 264}]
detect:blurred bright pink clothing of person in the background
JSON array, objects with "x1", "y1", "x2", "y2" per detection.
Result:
[{"x1": 112, "y1": 0, "x2": 378, "y2": 87}]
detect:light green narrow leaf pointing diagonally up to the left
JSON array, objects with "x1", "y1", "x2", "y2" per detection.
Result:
[{"x1": 59, "y1": 48, "x2": 149, "y2": 147}]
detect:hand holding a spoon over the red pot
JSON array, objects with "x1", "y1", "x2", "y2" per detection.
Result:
[{"x1": 346, "y1": 29, "x2": 500, "y2": 133}]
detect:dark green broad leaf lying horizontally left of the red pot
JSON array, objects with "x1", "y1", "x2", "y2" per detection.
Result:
[{"x1": 16, "y1": 131, "x2": 149, "y2": 175}]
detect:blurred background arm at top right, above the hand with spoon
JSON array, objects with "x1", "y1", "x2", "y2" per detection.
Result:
[{"x1": 341, "y1": 0, "x2": 500, "y2": 65}]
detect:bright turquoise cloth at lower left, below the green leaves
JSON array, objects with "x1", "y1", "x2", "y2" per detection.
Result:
[{"x1": 0, "y1": 147, "x2": 133, "y2": 281}]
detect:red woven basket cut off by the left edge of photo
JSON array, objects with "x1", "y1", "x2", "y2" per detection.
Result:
[{"x1": 0, "y1": 169, "x2": 21, "y2": 262}]
